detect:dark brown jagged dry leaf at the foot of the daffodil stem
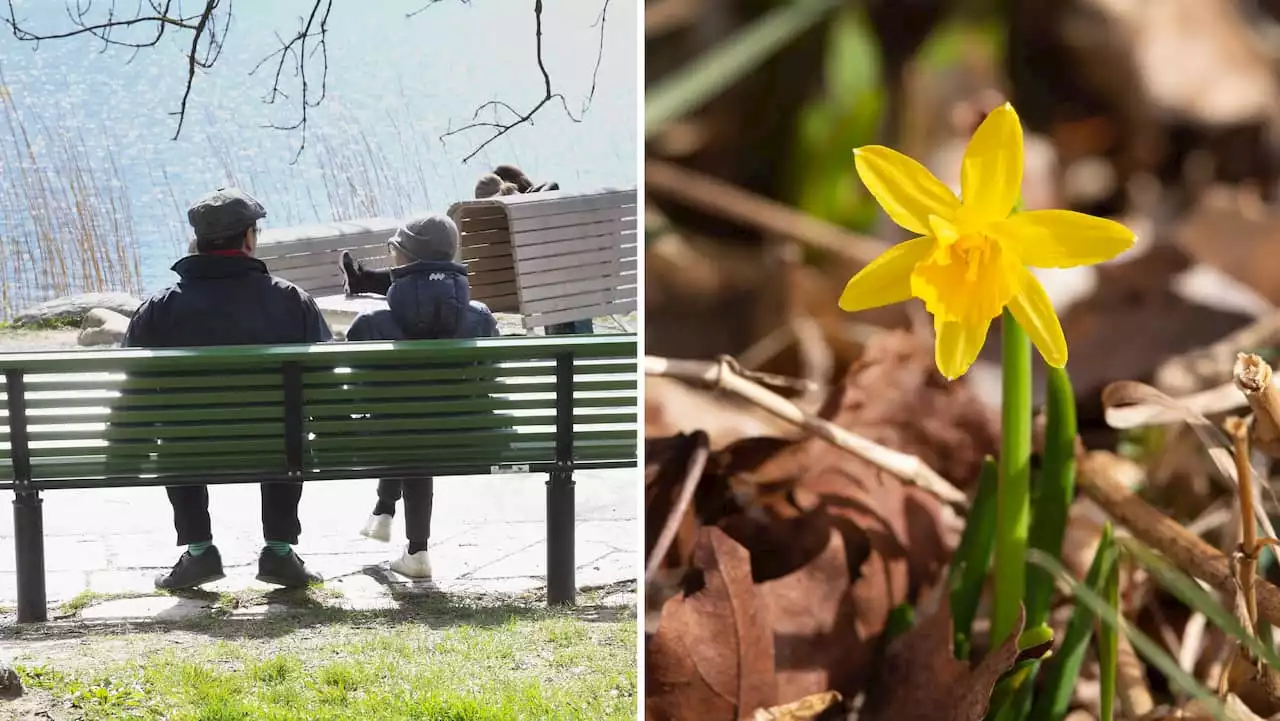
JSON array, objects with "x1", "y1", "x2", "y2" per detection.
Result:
[{"x1": 859, "y1": 594, "x2": 1024, "y2": 721}]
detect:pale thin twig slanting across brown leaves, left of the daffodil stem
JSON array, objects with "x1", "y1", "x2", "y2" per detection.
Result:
[{"x1": 644, "y1": 356, "x2": 969, "y2": 508}]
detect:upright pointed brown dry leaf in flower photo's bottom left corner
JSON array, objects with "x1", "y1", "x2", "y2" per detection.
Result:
[{"x1": 645, "y1": 528, "x2": 777, "y2": 721}]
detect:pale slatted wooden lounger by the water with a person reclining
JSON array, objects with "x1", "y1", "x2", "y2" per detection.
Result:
[{"x1": 256, "y1": 188, "x2": 639, "y2": 330}]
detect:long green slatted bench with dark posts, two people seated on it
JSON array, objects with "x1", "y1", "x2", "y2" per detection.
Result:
[{"x1": 0, "y1": 336, "x2": 639, "y2": 622}]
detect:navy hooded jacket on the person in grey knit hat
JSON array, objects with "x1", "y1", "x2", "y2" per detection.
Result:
[{"x1": 347, "y1": 260, "x2": 498, "y2": 341}]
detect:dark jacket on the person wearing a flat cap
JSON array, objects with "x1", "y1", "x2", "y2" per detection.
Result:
[{"x1": 122, "y1": 255, "x2": 333, "y2": 348}]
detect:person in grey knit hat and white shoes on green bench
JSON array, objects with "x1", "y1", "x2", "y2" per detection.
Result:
[{"x1": 347, "y1": 214, "x2": 498, "y2": 578}]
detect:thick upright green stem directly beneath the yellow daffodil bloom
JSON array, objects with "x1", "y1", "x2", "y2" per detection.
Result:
[{"x1": 991, "y1": 309, "x2": 1032, "y2": 648}]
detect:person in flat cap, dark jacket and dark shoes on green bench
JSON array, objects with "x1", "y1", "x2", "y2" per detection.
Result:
[{"x1": 123, "y1": 188, "x2": 333, "y2": 589}]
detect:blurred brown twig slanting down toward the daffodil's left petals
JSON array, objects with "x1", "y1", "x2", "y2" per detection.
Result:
[{"x1": 644, "y1": 158, "x2": 890, "y2": 265}]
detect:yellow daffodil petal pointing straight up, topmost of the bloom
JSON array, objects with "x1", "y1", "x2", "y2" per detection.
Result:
[{"x1": 960, "y1": 102, "x2": 1023, "y2": 223}]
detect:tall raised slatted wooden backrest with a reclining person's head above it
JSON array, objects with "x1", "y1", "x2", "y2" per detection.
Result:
[{"x1": 449, "y1": 188, "x2": 639, "y2": 329}]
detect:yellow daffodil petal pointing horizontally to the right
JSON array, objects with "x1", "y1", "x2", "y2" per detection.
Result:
[{"x1": 987, "y1": 210, "x2": 1135, "y2": 268}]
